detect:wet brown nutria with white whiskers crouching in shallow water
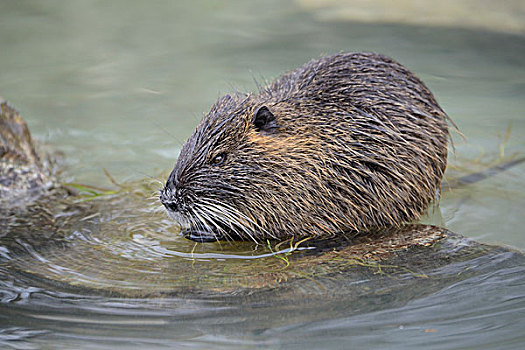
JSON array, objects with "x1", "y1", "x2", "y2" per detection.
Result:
[{"x1": 160, "y1": 53, "x2": 449, "y2": 241}]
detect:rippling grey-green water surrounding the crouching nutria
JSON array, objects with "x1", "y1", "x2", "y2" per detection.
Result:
[{"x1": 0, "y1": 1, "x2": 525, "y2": 349}]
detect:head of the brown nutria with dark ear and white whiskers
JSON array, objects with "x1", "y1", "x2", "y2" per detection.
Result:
[{"x1": 160, "y1": 91, "x2": 336, "y2": 241}]
